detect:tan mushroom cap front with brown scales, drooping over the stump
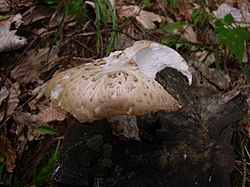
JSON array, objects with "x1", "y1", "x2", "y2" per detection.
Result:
[{"x1": 45, "y1": 59, "x2": 180, "y2": 122}]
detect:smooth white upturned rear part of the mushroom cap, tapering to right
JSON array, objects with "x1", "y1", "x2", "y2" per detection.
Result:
[{"x1": 105, "y1": 40, "x2": 192, "y2": 85}]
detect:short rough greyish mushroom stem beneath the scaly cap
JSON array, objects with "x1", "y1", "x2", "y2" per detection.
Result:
[{"x1": 108, "y1": 115, "x2": 140, "y2": 140}]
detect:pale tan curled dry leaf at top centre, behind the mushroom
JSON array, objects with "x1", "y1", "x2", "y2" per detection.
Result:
[{"x1": 117, "y1": 5, "x2": 162, "y2": 29}]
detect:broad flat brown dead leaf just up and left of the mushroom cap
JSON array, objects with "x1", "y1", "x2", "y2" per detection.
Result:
[{"x1": 11, "y1": 47, "x2": 58, "y2": 84}]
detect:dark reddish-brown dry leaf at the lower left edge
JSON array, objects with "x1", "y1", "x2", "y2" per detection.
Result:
[{"x1": 0, "y1": 136, "x2": 16, "y2": 172}]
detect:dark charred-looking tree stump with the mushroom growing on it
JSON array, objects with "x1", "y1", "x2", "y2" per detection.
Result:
[{"x1": 52, "y1": 68, "x2": 247, "y2": 187}]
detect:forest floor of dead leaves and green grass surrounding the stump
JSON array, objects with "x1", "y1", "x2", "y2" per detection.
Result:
[{"x1": 0, "y1": 0, "x2": 250, "y2": 186}]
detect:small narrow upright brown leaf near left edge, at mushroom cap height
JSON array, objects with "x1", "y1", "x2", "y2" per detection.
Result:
[{"x1": 6, "y1": 82, "x2": 20, "y2": 117}]
